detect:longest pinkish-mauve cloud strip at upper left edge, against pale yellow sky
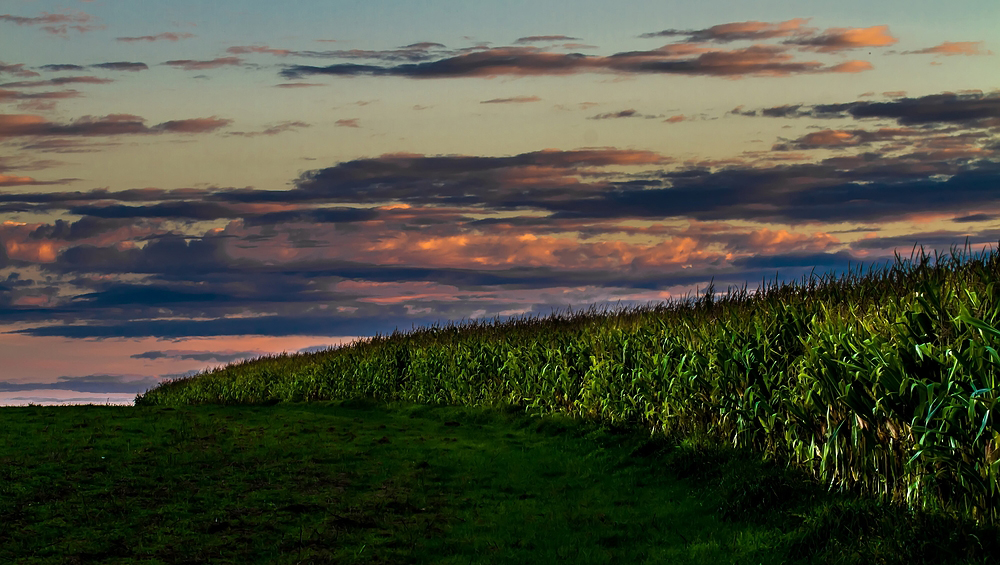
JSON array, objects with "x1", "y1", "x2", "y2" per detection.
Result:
[{"x1": 0, "y1": 114, "x2": 231, "y2": 139}]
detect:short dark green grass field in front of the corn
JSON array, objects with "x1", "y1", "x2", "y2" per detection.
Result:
[{"x1": 0, "y1": 401, "x2": 1000, "y2": 565}]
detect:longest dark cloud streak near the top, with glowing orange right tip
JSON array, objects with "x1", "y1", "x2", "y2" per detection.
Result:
[{"x1": 281, "y1": 45, "x2": 867, "y2": 79}]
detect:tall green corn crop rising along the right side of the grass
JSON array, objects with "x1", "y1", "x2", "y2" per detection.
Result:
[{"x1": 136, "y1": 247, "x2": 1000, "y2": 523}]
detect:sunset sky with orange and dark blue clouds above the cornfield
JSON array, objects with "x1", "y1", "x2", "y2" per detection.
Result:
[{"x1": 0, "y1": 0, "x2": 1000, "y2": 405}]
